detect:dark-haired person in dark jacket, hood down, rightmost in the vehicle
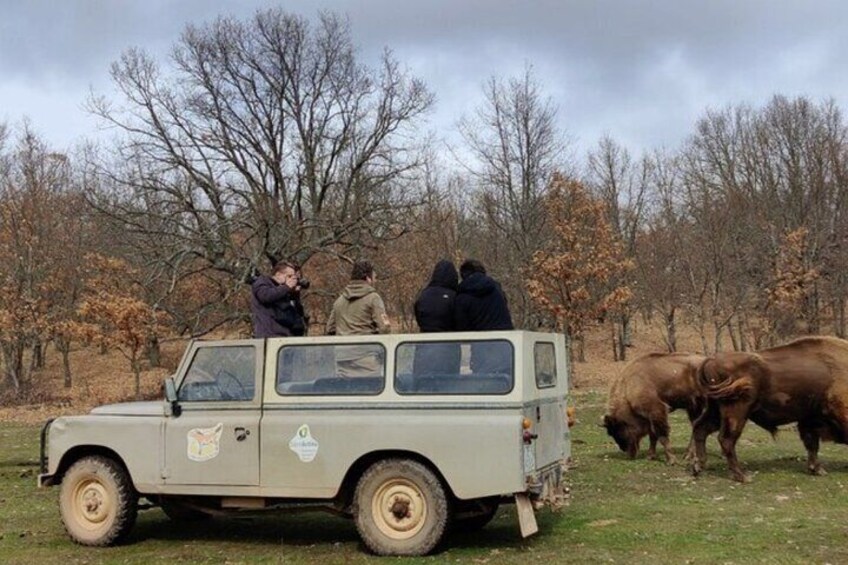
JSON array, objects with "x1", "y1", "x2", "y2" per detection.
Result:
[{"x1": 454, "y1": 259, "x2": 514, "y2": 374}]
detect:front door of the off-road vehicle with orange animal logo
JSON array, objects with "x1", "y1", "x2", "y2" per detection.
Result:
[{"x1": 163, "y1": 340, "x2": 264, "y2": 486}]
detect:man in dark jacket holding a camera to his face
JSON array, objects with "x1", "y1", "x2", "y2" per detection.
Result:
[{"x1": 250, "y1": 261, "x2": 309, "y2": 337}]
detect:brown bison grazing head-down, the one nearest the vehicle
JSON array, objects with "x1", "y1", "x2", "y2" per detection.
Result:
[{"x1": 604, "y1": 353, "x2": 707, "y2": 463}]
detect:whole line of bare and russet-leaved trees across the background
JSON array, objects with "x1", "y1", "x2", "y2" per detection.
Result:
[{"x1": 0, "y1": 10, "x2": 848, "y2": 398}]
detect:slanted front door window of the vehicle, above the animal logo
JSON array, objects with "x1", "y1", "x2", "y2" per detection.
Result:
[{"x1": 178, "y1": 345, "x2": 256, "y2": 402}]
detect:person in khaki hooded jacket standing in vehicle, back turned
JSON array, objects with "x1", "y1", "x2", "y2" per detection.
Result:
[{"x1": 326, "y1": 261, "x2": 392, "y2": 377}]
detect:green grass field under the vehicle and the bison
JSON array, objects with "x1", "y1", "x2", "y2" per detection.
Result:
[{"x1": 0, "y1": 392, "x2": 848, "y2": 565}]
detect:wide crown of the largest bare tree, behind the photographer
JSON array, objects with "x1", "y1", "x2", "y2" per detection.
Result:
[{"x1": 90, "y1": 9, "x2": 433, "y2": 332}]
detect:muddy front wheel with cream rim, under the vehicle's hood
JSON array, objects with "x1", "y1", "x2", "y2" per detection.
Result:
[{"x1": 59, "y1": 455, "x2": 138, "y2": 546}]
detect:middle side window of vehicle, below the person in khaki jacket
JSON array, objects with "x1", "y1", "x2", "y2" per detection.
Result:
[{"x1": 276, "y1": 343, "x2": 386, "y2": 396}]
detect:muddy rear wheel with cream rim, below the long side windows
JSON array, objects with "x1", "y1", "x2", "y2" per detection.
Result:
[{"x1": 354, "y1": 459, "x2": 449, "y2": 555}]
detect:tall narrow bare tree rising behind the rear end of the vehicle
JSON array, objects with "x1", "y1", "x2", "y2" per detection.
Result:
[{"x1": 459, "y1": 66, "x2": 567, "y2": 327}]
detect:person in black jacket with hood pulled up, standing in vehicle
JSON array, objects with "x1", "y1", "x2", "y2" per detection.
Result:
[{"x1": 413, "y1": 259, "x2": 461, "y2": 375}]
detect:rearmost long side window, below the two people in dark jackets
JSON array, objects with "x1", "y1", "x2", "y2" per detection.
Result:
[{"x1": 395, "y1": 340, "x2": 515, "y2": 394}]
